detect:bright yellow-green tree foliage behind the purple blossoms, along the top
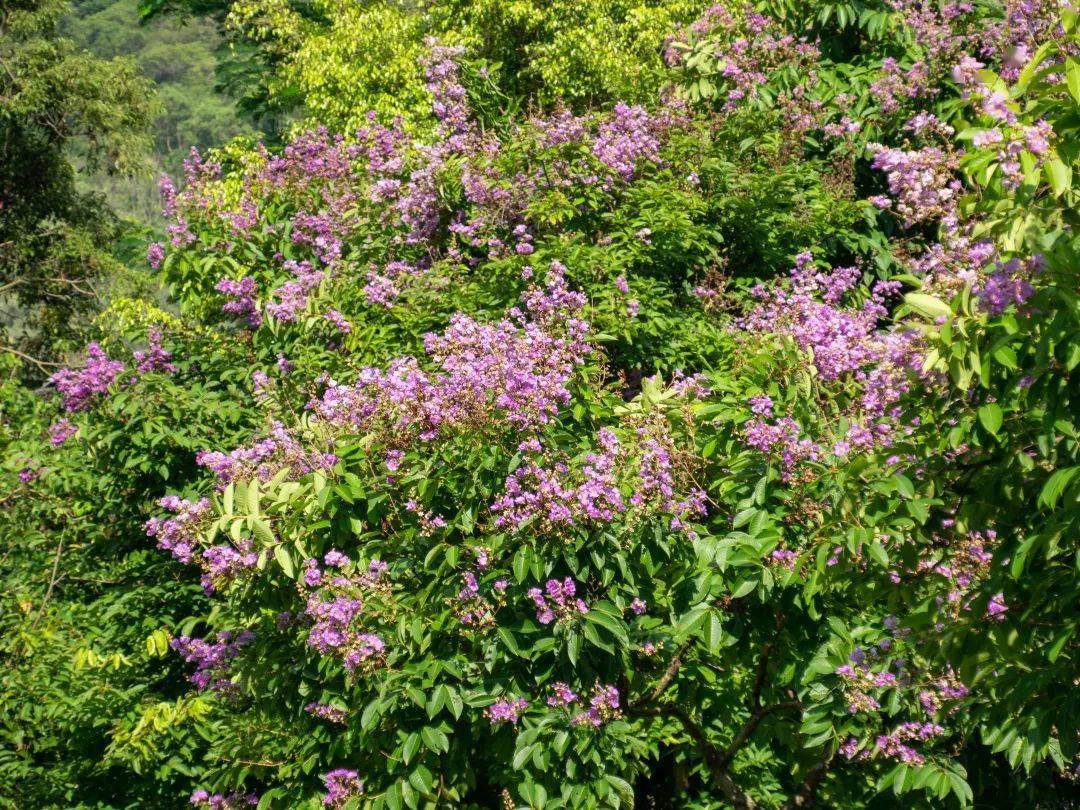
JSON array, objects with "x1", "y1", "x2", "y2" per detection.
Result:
[{"x1": 150, "y1": 0, "x2": 698, "y2": 132}]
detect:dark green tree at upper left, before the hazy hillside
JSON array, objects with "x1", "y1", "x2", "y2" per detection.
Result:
[{"x1": 0, "y1": 2, "x2": 156, "y2": 378}]
